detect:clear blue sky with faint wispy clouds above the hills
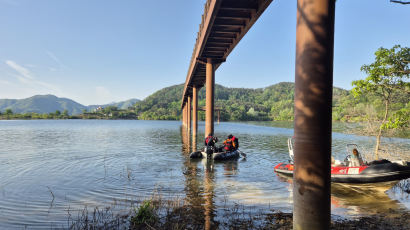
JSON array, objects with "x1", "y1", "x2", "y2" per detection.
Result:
[{"x1": 0, "y1": 0, "x2": 410, "y2": 105}]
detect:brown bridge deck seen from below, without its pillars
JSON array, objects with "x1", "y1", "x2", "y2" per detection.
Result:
[{"x1": 182, "y1": 0, "x2": 272, "y2": 107}]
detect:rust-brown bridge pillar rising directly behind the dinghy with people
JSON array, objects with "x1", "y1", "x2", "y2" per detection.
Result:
[{"x1": 205, "y1": 58, "x2": 215, "y2": 137}]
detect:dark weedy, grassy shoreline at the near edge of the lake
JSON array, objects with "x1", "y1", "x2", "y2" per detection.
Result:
[{"x1": 68, "y1": 194, "x2": 410, "y2": 230}]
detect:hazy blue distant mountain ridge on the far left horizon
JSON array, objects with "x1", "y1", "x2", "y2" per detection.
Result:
[{"x1": 0, "y1": 95, "x2": 140, "y2": 115}]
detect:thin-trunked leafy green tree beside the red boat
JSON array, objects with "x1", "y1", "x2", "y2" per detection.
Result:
[{"x1": 352, "y1": 45, "x2": 410, "y2": 159}]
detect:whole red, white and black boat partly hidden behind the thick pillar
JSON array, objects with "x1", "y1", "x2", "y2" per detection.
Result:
[{"x1": 275, "y1": 138, "x2": 410, "y2": 183}]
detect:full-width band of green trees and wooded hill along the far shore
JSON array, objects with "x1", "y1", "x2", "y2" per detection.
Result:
[{"x1": 0, "y1": 82, "x2": 410, "y2": 137}]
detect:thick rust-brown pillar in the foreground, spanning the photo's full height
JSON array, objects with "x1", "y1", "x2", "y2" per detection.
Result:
[{"x1": 293, "y1": 0, "x2": 335, "y2": 229}]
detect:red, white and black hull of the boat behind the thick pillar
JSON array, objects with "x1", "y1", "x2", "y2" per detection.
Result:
[{"x1": 275, "y1": 163, "x2": 410, "y2": 183}]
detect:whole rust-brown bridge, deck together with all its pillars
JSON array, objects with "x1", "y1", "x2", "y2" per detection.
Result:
[{"x1": 181, "y1": 0, "x2": 335, "y2": 229}]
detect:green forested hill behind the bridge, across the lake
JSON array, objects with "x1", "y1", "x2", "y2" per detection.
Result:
[{"x1": 136, "y1": 82, "x2": 349, "y2": 121}]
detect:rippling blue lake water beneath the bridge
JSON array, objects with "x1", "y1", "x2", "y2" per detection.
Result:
[{"x1": 0, "y1": 120, "x2": 410, "y2": 229}]
